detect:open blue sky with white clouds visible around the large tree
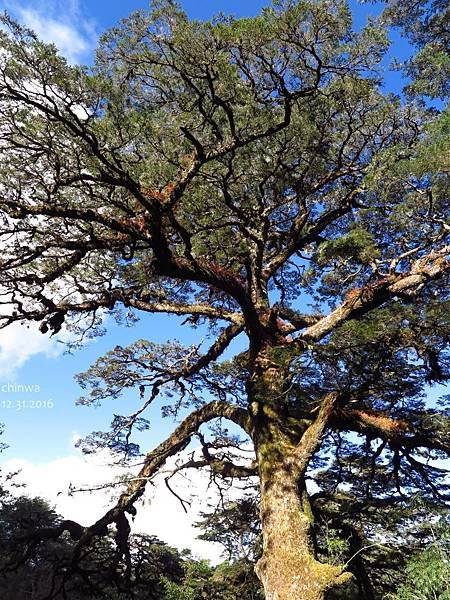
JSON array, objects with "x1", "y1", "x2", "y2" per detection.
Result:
[{"x1": 0, "y1": 0, "x2": 444, "y2": 558}]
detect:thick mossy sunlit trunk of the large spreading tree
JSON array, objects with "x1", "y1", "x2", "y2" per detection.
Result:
[{"x1": 249, "y1": 349, "x2": 351, "y2": 600}]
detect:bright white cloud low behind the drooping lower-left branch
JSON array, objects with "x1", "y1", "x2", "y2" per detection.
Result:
[{"x1": 2, "y1": 446, "x2": 229, "y2": 563}]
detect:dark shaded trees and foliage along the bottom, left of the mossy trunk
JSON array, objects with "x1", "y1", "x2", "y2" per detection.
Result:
[{"x1": 0, "y1": 474, "x2": 263, "y2": 600}]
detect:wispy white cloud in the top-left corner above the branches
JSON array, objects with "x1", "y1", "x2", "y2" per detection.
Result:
[{"x1": 0, "y1": 0, "x2": 98, "y2": 63}]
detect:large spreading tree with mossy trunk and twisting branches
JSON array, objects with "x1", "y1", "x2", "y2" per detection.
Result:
[{"x1": 0, "y1": 0, "x2": 450, "y2": 600}]
